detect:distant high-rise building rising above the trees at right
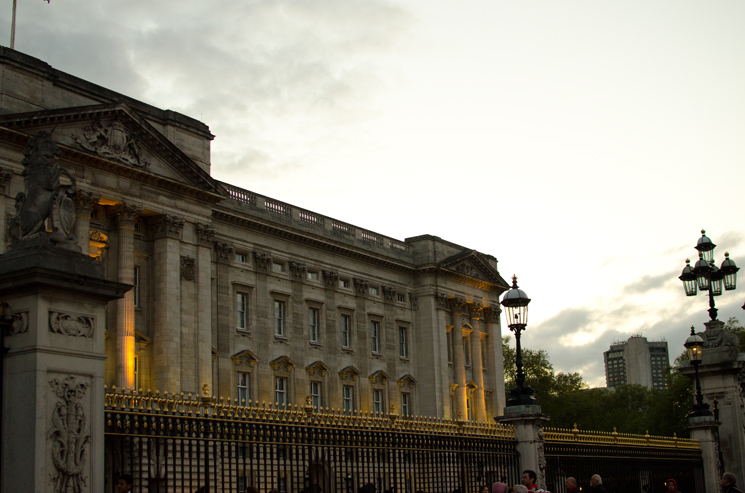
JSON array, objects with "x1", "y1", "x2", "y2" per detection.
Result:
[{"x1": 603, "y1": 335, "x2": 670, "y2": 389}]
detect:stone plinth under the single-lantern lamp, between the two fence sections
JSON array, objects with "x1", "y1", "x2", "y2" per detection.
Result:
[{"x1": 494, "y1": 405, "x2": 549, "y2": 490}]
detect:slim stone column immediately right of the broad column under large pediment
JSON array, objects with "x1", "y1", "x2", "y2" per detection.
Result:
[{"x1": 195, "y1": 224, "x2": 215, "y2": 397}]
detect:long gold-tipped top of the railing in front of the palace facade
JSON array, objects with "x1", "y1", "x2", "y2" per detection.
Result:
[{"x1": 104, "y1": 387, "x2": 515, "y2": 440}]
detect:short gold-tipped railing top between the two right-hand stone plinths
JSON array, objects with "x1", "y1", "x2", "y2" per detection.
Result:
[{"x1": 543, "y1": 423, "x2": 701, "y2": 449}]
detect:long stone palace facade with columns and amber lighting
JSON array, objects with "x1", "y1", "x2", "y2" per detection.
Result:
[{"x1": 0, "y1": 48, "x2": 508, "y2": 421}]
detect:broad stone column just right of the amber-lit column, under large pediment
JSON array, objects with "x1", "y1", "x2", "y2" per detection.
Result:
[{"x1": 148, "y1": 215, "x2": 184, "y2": 392}]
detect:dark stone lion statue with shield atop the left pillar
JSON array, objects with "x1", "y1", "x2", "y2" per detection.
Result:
[{"x1": 8, "y1": 131, "x2": 80, "y2": 252}]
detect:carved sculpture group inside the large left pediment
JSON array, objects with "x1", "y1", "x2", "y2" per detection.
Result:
[{"x1": 72, "y1": 118, "x2": 150, "y2": 167}]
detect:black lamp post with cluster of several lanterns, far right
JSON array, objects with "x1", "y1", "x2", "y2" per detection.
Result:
[{"x1": 678, "y1": 229, "x2": 745, "y2": 320}]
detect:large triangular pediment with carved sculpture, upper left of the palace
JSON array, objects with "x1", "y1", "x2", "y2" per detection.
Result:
[{"x1": 0, "y1": 103, "x2": 226, "y2": 198}]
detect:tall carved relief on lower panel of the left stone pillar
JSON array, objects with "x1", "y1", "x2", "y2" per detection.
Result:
[{"x1": 48, "y1": 375, "x2": 90, "y2": 493}]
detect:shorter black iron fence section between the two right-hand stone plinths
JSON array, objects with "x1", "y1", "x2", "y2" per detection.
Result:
[{"x1": 544, "y1": 426, "x2": 705, "y2": 493}]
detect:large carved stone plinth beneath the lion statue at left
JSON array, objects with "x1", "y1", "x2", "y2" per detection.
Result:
[{"x1": 0, "y1": 242, "x2": 131, "y2": 492}]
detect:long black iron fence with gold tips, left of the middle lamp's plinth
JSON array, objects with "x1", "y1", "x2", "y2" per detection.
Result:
[{"x1": 105, "y1": 393, "x2": 519, "y2": 493}]
